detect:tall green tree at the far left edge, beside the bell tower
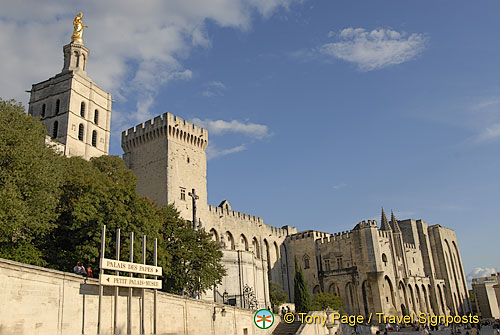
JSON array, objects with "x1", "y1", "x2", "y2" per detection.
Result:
[{"x1": 0, "y1": 99, "x2": 63, "y2": 265}]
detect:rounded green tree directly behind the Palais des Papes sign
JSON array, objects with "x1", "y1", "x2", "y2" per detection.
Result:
[{"x1": 45, "y1": 156, "x2": 166, "y2": 271}]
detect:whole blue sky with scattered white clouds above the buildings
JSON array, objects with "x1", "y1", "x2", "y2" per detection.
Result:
[{"x1": 0, "y1": 0, "x2": 500, "y2": 275}]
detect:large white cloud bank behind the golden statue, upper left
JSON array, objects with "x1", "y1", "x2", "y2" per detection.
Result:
[{"x1": 0, "y1": 0, "x2": 300, "y2": 128}]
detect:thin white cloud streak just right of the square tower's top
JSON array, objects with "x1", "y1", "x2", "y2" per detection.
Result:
[{"x1": 192, "y1": 118, "x2": 271, "y2": 139}]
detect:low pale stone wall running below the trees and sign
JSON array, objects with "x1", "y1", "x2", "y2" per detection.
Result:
[{"x1": 0, "y1": 259, "x2": 278, "y2": 335}]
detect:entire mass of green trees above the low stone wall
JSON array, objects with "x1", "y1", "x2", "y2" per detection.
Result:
[{"x1": 0, "y1": 99, "x2": 225, "y2": 293}]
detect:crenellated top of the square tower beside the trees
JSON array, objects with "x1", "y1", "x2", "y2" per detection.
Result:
[{"x1": 122, "y1": 113, "x2": 208, "y2": 152}]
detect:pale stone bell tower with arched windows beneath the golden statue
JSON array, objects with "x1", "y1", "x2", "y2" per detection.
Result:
[{"x1": 28, "y1": 16, "x2": 111, "y2": 159}]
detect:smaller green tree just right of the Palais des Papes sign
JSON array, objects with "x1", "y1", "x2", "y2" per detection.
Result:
[{"x1": 159, "y1": 205, "x2": 226, "y2": 294}]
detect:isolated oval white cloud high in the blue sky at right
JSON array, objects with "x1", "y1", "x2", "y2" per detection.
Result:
[{"x1": 320, "y1": 28, "x2": 428, "y2": 71}]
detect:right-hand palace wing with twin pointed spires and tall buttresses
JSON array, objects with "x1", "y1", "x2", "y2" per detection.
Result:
[{"x1": 285, "y1": 214, "x2": 471, "y2": 316}]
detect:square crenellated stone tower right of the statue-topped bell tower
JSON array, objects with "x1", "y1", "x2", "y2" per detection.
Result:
[{"x1": 122, "y1": 113, "x2": 208, "y2": 221}]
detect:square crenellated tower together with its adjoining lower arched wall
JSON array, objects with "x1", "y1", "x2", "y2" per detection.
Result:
[{"x1": 122, "y1": 113, "x2": 296, "y2": 307}]
